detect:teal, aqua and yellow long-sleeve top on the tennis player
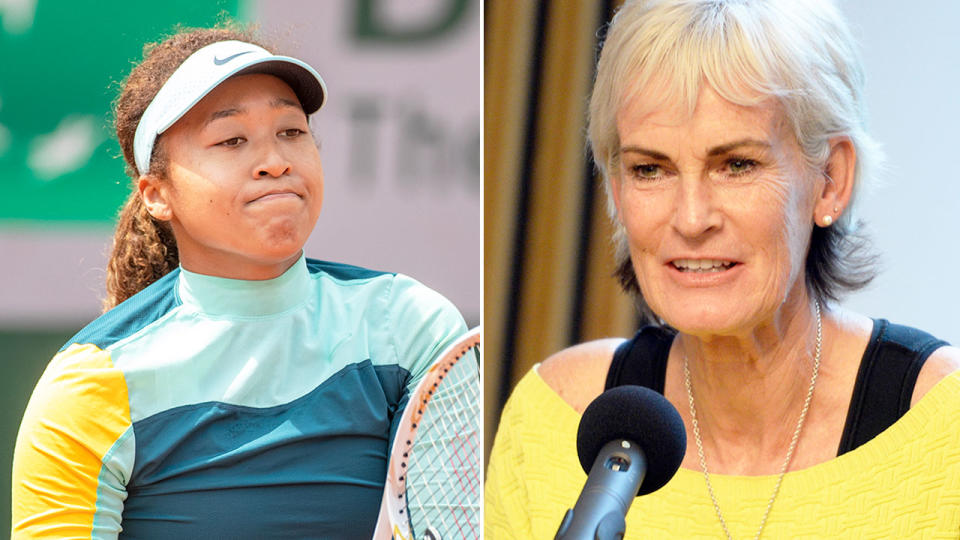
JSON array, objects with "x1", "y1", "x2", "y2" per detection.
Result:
[{"x1": 13, "y1": 254, "x2": 465, "y2": 539}]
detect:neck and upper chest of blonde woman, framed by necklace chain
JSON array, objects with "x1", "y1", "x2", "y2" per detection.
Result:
[{"x1": 668, "y1": 296, "x2": 829, "y2": 472}]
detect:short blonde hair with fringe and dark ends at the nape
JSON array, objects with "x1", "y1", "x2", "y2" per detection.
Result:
[{"x1": 588, "y1": 0, "x2": 882, "y2": 314}]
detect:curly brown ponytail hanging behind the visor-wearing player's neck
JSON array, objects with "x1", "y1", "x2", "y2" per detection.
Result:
[{"x1": 103, "y1": 190, "x2": 180, "y2": 311}]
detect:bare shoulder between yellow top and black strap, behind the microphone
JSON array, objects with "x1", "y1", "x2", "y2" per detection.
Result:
[{"x1": 537, "y1": 338, "x2": 624, "y2": 413}]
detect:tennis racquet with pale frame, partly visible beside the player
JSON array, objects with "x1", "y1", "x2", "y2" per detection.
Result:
[{"x1": 373, "y1": 327, "x2": 483, "y2": 540}]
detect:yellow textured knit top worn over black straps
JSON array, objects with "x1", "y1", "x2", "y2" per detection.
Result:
[{"x1": 484, "y1": 370, "x2": 960, "y2": 540}]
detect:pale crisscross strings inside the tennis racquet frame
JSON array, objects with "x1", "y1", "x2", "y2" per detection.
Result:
[{"x1": 407, "y1": 346, "x2": 483, "y2": 540}]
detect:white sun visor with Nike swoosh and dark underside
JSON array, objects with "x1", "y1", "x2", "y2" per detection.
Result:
[{"x1": 133, "y1": 41, "x2": 327, "y2": 175}]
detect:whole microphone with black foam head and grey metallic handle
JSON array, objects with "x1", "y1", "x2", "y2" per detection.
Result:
[{"x1": 554, "y1": 385, "x2": 687, "y2": 540}]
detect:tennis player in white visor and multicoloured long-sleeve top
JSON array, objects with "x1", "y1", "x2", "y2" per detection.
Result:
[{"x1": 12, "y1": 28, "x2": 465, "y2": 539}]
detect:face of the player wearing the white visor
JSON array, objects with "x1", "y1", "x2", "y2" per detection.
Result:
[{"x1": 139, "y1": 74, "x2": 323, "y2": 279}]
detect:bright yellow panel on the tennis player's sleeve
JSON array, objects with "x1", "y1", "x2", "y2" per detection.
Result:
[{"x1": 12, "y1": 345, "x2": 132, "y2": 539}]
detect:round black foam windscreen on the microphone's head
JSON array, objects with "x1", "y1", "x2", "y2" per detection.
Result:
[{"x1": 577, "y1": 385, "x2": 687, "y2": 495}]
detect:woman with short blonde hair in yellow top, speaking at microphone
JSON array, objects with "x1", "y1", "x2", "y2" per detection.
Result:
[{"x1": 486, "y1": 0, "x2": 960, "y2": 538}]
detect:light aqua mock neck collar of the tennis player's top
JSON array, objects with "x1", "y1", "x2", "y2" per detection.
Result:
[{"x1": 177, "y1": 253, "x2": 310, "y2": 317}]
